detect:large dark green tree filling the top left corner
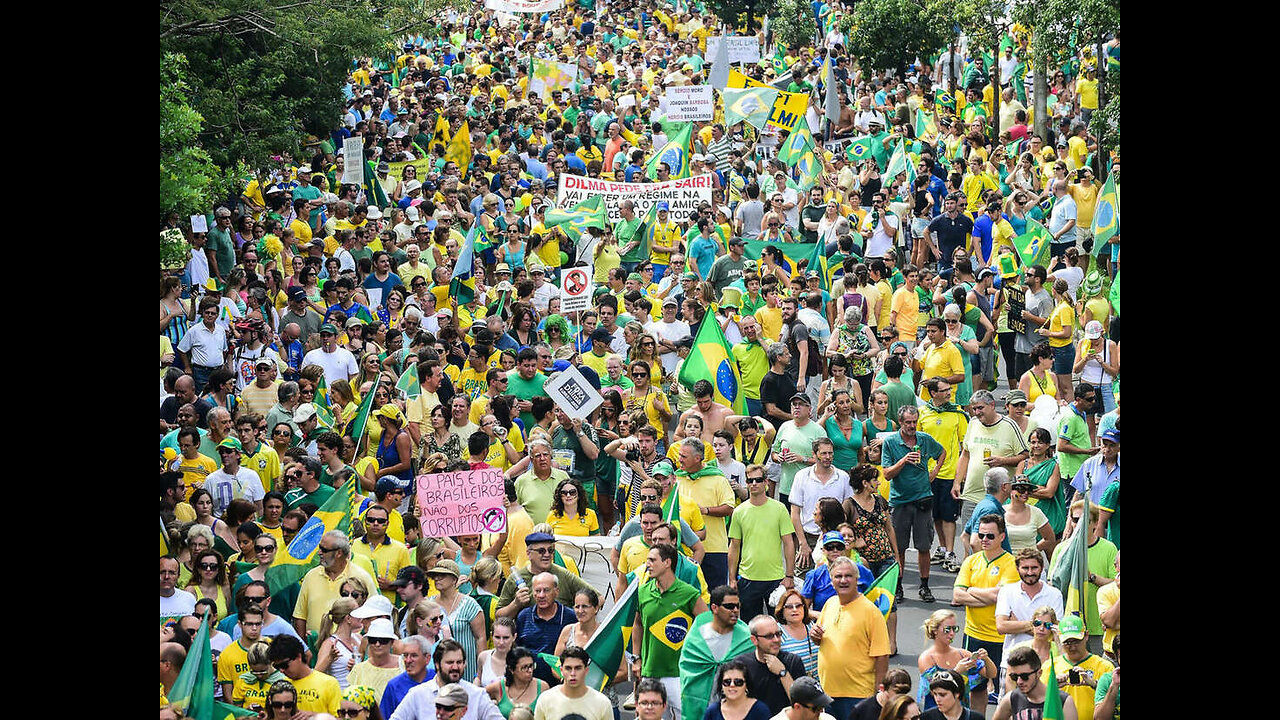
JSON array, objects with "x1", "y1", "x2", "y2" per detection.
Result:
[{"x1": 159, "y1": 0, "x2": 460, "y2": 168}]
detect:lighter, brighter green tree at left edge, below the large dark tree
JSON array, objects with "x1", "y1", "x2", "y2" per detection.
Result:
[{"x1": 160, "y1": 53, "x2": 242, "y2": 218}]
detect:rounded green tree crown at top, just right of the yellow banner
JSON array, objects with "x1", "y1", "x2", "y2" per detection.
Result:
[{"x1": 842, "y1": 0, "x2": 954, "y2": 70}]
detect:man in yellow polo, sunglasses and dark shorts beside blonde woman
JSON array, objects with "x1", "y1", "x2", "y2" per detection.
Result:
[{"x1": 951, "y1": 514, "x2": 1021, "y2": 714}]
